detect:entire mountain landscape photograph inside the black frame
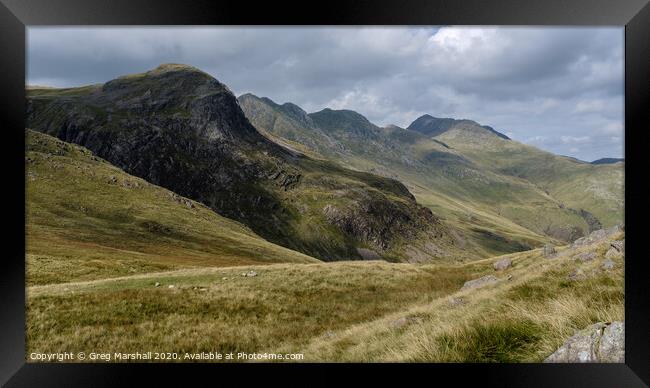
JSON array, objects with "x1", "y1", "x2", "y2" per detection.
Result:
[{"x1": 25, "y1": 26, "x2": 625, "y2": 363}]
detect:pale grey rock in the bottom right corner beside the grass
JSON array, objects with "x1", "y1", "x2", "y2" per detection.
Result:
[{"x1": 544, "y1": 321, "x2": 625, "y2": 363}]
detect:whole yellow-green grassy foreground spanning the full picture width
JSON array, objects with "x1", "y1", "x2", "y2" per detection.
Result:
[{"x1": 27, "y1": 229, "x2": 624, "y2": 362}]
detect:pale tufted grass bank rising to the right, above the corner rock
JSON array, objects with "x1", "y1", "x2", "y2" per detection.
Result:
[{"x1": 301, "y1": 230, "x2": 625, "y2": 362}]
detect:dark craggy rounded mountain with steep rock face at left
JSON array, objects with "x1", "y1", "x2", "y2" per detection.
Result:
[{"x1": 27, "y1": 65, "x2": 444, "y2": 260}]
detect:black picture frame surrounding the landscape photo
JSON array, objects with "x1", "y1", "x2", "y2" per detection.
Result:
[{"x1": 0, "y1": 0, "x2": 650, "y2": 387}]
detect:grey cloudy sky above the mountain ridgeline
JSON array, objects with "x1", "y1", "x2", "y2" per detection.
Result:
[{"x1": 26, "y1": 27, "x2": 624, "y2": 161}]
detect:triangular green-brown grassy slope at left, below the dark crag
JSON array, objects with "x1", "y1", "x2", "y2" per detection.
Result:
[{"x1": 25, "y1": 130, "x2": 317, "y2": 285}]
